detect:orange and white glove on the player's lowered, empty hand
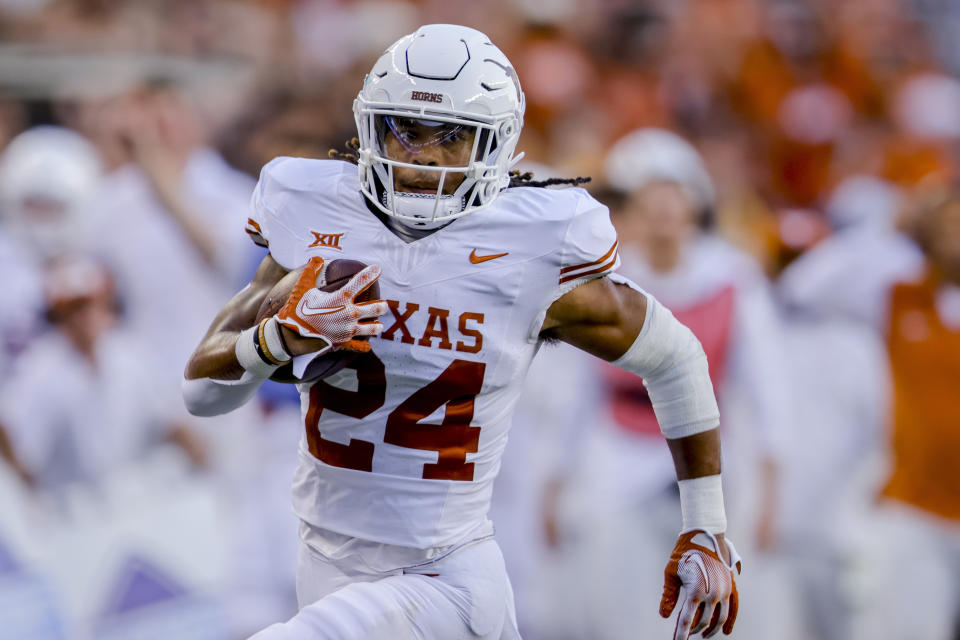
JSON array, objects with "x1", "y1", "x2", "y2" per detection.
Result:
[{"x1": 660, "y1": 529, "x2": 740, "y2": 640}]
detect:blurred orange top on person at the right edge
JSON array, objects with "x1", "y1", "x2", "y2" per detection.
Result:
[{"x1": 883, "y1": 275, "x2": 960, "y2": 520}]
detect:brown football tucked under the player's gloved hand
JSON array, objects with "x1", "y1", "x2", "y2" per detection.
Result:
[{"x1": 257, "y1": 259, "x2": 380, "y2": 384}]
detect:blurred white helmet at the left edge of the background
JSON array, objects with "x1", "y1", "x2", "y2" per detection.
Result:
[{"x1": 0, "y1": 126, "x2": 103, "y2": 257}]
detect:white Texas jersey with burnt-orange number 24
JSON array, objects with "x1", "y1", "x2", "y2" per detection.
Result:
[{"x1": 247, "y1": 158, "x2": 619, "y2": 549}]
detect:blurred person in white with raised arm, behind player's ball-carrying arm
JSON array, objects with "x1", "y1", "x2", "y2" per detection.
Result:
[{"x1": 75, "y1": 84, "x2": 254, "y2": 402}]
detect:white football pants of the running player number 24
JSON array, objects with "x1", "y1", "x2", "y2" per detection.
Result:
[{"x1": 251, "y1": 538, "x2": 520, "y2": 640}]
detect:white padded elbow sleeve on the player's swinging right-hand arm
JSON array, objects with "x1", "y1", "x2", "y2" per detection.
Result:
[{"x1": 613, "y1": 293, "x2": 720, "y2": 438}]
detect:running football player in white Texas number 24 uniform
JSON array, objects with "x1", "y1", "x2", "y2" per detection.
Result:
[{"x1": 184, "y1": 25, "x2": 739, "y2": 639}]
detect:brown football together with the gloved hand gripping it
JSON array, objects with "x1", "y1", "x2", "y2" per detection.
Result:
[{"x1": 257, "y1": 257, "x2": 388, "y2": 382}]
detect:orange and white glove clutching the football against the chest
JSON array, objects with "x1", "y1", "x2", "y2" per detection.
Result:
[{"x1": 276, "y1": 257, "x2": 389, "y2": 352}]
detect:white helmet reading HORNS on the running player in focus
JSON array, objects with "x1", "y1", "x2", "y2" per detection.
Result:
[{"x1": 353, "y1": 24, "x2": 524, "y2": 229}]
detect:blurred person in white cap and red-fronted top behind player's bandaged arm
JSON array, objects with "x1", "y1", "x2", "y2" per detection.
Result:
[{"x1": 528, "y1": 128, "x2": 789, "y2": 640}]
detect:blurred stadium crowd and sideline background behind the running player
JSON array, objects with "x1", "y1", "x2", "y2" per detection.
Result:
[{"x1": 0, "y1": 0, "x2": 960, "y2": 640}]
